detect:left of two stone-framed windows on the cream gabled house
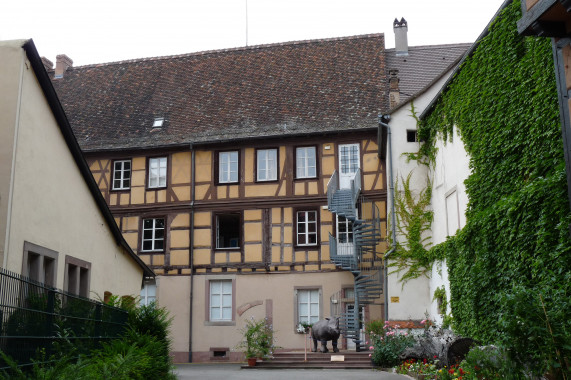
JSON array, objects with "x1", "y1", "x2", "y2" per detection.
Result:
[{"x1": 22, "y1": 241, "x2": 58, "y2": 287}]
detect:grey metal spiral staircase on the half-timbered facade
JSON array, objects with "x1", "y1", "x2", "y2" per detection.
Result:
[{"x1": 327, "y1": 170, "x2": 383, "y2": 351}]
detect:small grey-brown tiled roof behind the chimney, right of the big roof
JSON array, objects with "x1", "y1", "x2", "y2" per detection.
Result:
[{"x1": 386, "y1": 43, "x2": 472, "y2": 104}]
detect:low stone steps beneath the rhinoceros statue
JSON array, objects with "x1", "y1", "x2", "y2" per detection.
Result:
[{"x1": 242, "y1": 350, "x2": 373, "y2": 369}]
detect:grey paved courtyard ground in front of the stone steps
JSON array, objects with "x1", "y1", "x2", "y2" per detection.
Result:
[{"x1": 175, "y1": 363, "x2": 410, "y2": 380}]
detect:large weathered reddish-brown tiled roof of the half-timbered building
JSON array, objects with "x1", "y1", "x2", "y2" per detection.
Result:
[{"x1": 54, "y1": 34, "x2": 388, "y2": 150}]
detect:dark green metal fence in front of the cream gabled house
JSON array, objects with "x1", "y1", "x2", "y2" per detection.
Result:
[{"x1": 0, "y1": 268, "x2": 128, "y2": 369}]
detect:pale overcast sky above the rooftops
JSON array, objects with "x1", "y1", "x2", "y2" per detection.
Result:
[{"x1": 0, "y1": 0, "x2": 503, "y2": 66}]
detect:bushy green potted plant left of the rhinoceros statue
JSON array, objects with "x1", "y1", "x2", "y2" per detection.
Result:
[{"x1": 237, "y1": 318, "x2": 274, "y2": 366}]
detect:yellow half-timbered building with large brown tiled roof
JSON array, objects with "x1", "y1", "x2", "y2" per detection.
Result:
[{"x1": 47, "y1": 30, "x2": 470, "y2": 362}]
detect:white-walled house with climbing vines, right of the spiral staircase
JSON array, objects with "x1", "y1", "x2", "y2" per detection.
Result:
[{"x1": 387, "y1": 61, "x2": 469, "y2": 325}]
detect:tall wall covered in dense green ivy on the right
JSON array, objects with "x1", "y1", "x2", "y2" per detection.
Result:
[{"x1": 419, "y1": 1, "x2": 571, "y2": 361}]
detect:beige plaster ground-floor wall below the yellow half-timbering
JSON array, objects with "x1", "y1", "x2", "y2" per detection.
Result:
[{"x1": 181, "y1": 272, "x2": 358, "y2": 360}]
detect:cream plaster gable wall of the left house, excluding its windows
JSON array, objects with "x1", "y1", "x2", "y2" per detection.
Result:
[{"x1": 3, "y1": 40, "x2": 142, "y2": 297}]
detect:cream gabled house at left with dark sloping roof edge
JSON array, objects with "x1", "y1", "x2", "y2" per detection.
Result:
[{"x1": 0, "y1": 40, "x2": 154, "y2": 298}]
